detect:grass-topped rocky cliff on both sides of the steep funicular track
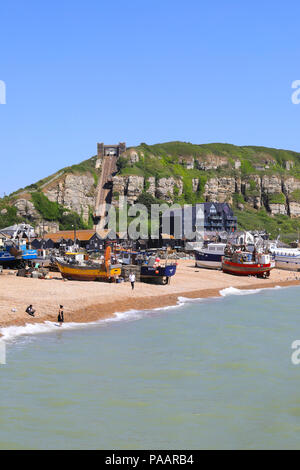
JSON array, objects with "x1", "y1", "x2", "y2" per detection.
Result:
[{"x1": 7, "y1": 142, "x2": 300, "y2": 233}]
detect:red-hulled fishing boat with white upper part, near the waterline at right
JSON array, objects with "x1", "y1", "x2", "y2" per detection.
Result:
[{"x1": 222, "y1": 250, "x2": 275, "y2": 278}]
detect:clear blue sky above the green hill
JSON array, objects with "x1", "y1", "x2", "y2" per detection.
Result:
[{"x1": 0, "y1": 0, "x2": 300, "y2": 196}]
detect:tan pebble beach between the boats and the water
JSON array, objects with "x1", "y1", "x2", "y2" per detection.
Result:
[{"x1": 0, "y1": 260, "x2": 300, "y2": 327}]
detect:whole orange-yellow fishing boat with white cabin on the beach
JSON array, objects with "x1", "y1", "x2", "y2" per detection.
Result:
[{"x1": 56, "y1": 246, "x2": 121, "y2": 282}]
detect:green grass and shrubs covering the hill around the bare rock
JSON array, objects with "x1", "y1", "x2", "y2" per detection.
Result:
[{"x1": 0, "y1": 142, "x2": 300, "y2": 240}]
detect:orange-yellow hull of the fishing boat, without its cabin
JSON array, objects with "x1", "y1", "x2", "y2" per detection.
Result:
[{"x1": 56, "y1": 260, "x2": 121, "y2": 281}]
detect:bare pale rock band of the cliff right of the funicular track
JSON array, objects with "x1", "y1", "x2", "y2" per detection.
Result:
[{"x1": 113, "y1": 175, "x2": 300, "y2": 217}]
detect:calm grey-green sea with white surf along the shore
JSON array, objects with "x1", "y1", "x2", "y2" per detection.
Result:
[{"x1": 0, "y1": 287, "x2": 300, "y2": 450}]
